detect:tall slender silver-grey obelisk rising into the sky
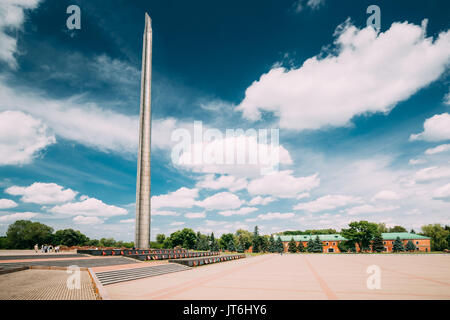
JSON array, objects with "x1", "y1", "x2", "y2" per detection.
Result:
[{"x1": 134, "y1": 13, "x2": 152, "y2": 249}]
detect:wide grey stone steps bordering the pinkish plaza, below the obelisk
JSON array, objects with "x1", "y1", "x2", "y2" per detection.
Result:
[{"x1": 95, "y1": 263, "x2": 191, "y2": 285}]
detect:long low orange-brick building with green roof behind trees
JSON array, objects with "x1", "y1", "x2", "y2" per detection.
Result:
[{"x1": 274, "y1": 232, "x2": 430, "y2": 253}]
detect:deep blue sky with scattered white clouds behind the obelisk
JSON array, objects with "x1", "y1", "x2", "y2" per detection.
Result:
[{"x1": 0, "y1": 0, "x2": 450, "y2": 240}]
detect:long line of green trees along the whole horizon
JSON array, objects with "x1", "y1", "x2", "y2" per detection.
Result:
[{"x1": 0, "y1": 220, "x2": 450, "y2": 253}]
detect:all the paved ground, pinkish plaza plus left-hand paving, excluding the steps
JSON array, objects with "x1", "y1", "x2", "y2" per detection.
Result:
[{"x1": 0, "y1": 254, "x2": 450, "y2": 300}]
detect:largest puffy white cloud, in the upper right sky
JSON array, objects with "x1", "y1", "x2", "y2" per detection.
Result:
[{"x1": 237, "y1": 21, "x2": 450, "y2": 130}]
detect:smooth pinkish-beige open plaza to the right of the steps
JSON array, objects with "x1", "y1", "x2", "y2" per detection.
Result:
[{"x1": 103, "y1": 254, "x2": 450, "y2": 300}]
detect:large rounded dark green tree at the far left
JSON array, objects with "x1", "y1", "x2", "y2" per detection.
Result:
[{"x1": 6, "y1": 220, "x2": 53, "y2": 249}]
